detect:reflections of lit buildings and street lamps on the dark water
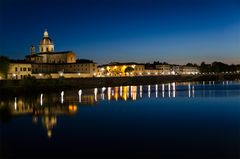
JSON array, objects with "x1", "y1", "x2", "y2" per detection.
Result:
[{"x1": 10, "y1": 81, "x2": 238, "y2": 137}]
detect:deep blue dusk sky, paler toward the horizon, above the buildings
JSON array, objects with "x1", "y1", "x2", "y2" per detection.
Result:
[{"x1": 0, "y1": 0, "x2": 240, "y2": 64}]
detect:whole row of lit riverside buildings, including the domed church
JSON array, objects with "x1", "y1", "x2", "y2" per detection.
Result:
[{"x1": 1, "y1": 31, "x2": 199, "y2": 79}]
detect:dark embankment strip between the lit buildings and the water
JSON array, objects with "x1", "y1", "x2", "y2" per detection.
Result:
[{"x1": 0, "y1": 74, "x2": 240, "y2": 95}]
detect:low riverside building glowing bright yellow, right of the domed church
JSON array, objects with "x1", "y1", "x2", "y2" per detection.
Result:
[{"x1": 98, "y1": 62, "x2": 145, "y2": 77}]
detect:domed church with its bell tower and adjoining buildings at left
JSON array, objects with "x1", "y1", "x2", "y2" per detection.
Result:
[{"x1": 4, "y1": 30, "x2": 97, "y2": 79}]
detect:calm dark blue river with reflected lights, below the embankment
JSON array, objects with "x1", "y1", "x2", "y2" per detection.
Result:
[{"x1": 0, "y1": 81, "x2": 240, "y2": 159}]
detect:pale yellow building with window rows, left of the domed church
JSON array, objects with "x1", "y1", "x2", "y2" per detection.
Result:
[{"x1": 7, "y1": 60, "x2": 32, "y2": 79}]
